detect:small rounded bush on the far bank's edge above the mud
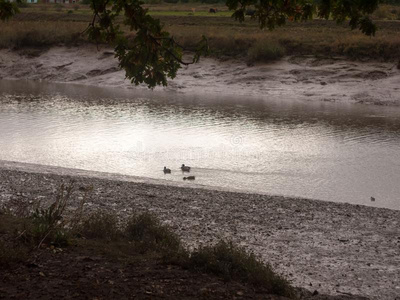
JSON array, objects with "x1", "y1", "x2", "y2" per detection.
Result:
[{"x1": 247, "y1": 40, "x2": 285, "y2": 62}]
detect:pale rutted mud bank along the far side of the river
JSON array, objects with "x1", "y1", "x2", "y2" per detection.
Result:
[{"x1": 0, "y1": 46, "x2": 400, "y2": 106}]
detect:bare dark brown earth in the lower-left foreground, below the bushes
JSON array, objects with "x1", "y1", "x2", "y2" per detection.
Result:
[{"x1": 0, "y1": 220, "x2": 365, "y2": 300}]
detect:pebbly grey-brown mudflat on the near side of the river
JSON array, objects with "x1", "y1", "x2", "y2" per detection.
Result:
[{"x1": 0, "y1": 161, "x2": 400, "y2": 300}]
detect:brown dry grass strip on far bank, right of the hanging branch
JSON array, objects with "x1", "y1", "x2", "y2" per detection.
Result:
[{"x1": 168, "y1": 21, "x2": 400, "y2": 60}]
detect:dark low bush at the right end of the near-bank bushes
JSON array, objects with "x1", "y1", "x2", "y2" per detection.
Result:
[{"x1": 189, "y1": 241, "x2": 294, "y2": 297}]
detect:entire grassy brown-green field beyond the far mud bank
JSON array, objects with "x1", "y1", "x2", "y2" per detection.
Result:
[{"x1": 0, "y1": 3, "x2": 400, "y2": 62}]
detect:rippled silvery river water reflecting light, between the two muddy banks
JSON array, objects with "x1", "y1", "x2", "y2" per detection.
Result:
[{"x1": 0, "y1": 80, "x2": 400, "y2": 209}]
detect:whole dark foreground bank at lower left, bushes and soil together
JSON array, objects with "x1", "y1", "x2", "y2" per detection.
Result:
[{"x1": 0, "y1": 185, "x2": 295, "y2": 298}]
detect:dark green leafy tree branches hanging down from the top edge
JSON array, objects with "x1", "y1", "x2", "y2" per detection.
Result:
[{"x1": 0, "y1": 0, "x2": 380, "y2": 88}]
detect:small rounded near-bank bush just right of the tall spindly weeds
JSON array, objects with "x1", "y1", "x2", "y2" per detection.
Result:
[{"x1": 77, "y1": 211, "x2": 120, "y2": 241}]
